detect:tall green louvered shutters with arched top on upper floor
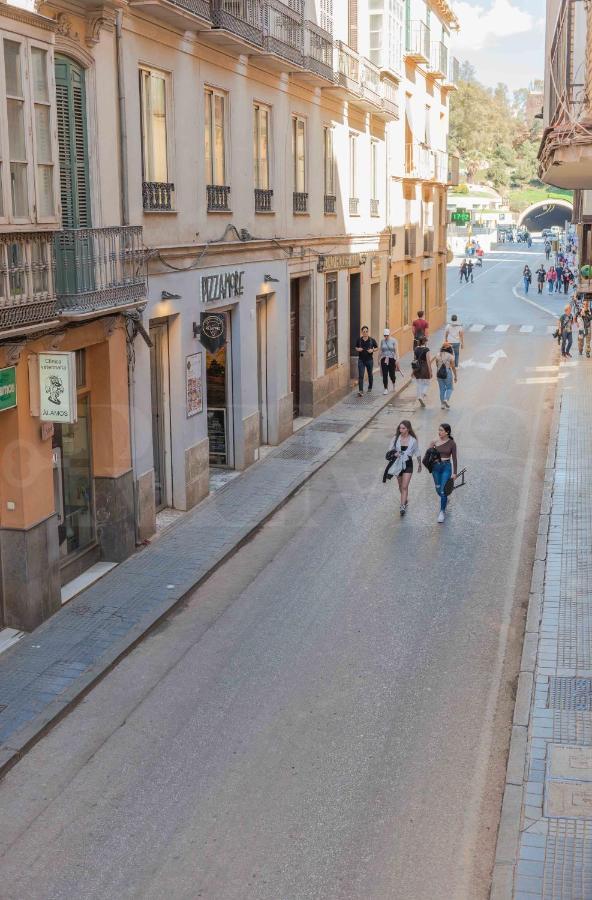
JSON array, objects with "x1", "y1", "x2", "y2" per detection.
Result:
[{"x1": 55, "y1": 56, "x2": 91, "y2": 228}]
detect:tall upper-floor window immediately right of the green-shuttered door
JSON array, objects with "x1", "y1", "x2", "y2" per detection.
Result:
[{"x1": 140, "y1": 69, "x2": 170, "y2": 184}]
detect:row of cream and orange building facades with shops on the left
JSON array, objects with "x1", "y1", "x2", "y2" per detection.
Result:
[{"x1": 0, "y1": 0, "x2": 458, "y2": 628}]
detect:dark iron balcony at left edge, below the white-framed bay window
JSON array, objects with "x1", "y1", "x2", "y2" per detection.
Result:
[{"x1": 0, "y1": 232, "x2": 57, "y2": 337}]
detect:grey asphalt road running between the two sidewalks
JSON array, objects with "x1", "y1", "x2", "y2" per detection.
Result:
[{"x1": 0, "y1": 243, "x2": 559, "y2": 900}]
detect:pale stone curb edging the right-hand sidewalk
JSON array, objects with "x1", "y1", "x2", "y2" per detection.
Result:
[{"x1": 489, "y1": 376, "x2": 562, "y2": 900}]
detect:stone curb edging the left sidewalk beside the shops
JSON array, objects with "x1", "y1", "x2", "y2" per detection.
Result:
[{"x1": 0, "y1": 375, "x2": 411, "y2": 779}]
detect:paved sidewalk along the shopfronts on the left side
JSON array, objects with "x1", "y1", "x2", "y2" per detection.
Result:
[{"x1": 0, "y1": 355, "x2": 411, "y2": 775}]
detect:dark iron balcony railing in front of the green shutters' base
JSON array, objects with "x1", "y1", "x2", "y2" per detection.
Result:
[{"x1": 54, "y1": 225, "x2": 146, "y2": 312}]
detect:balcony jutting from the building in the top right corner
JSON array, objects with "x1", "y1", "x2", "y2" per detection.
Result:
[{"x1": 539, "y1": 0, "x2": 592, "y2": 190}]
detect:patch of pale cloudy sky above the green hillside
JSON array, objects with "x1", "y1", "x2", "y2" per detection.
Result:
[{"x1": 451, "y1": 0, "x2": 546, "y2": 90}]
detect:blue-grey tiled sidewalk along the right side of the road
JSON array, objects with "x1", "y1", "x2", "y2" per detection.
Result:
[{"x1": 491, "y1": 351, "x2": 592, "y2": 900}]
